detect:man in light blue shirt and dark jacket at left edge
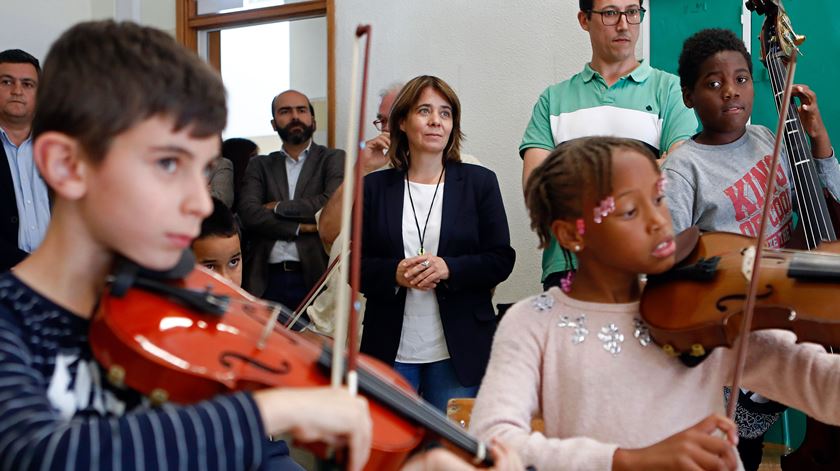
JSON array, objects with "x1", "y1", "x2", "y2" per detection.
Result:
[{"x1": 0, "y1": 49, "x2": 50, "y2": 271}]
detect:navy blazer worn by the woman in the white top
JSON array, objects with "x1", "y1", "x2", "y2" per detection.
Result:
[{"x1": 361, "y1": 162, "x2": 516, "y2": 386}]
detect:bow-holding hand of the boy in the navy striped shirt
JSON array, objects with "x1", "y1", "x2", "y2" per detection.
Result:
[{"x1": 254, "y1": 387, "x2": 373, "y2": 471}]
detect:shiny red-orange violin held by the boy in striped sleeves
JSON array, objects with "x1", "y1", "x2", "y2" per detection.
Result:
[{"x1": 90, "y1": 264, "x2": 492, "y2": 470}]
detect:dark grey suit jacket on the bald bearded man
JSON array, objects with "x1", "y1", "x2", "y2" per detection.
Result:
[{"x1": 237, "y1": 142, "x2": 344, "y2": 296}]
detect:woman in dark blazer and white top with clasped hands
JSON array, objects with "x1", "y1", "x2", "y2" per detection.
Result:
[{"x1": 361, "y1": 76, "x2": 516, "y2": 410}]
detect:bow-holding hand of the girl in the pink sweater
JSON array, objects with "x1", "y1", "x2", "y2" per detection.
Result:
[{"x1": 613, "y1": 414, "x2": 738, "y2": 471}]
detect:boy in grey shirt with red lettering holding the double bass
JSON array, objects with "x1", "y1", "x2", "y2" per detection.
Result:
[{"x1": 662, "y1": 29, "x2": 840, "y2": 471}]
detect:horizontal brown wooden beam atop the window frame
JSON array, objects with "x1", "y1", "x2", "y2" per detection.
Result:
[{"x1": 188, "y1": 0, "x2": 327, "y2": 30}]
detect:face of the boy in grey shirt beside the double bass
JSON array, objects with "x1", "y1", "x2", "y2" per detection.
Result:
[{"x1": 683, "y1": 51, "x2": 754, "y2": 145}]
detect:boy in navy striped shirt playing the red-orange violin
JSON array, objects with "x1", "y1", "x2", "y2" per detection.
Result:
[{"x1": 0, "y1": 21, "x2": 371, "y2": 470}]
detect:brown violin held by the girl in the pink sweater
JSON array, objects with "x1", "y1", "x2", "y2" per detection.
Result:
[{"x1": 640, "y1": 232, "x2": 840, "y2": 357}]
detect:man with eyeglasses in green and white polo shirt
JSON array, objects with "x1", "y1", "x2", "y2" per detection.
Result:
[{"x1": 519, "y1": 0, "x2": 697, "y2": 289}]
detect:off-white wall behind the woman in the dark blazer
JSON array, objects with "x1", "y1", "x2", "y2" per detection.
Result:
[{"x1": 336, "y1": 0, "x2": 612, "y2": 302}]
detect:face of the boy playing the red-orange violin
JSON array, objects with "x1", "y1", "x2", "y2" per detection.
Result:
[{"x1": 77, "y1": 116, "x2": 219, "y2": 270}]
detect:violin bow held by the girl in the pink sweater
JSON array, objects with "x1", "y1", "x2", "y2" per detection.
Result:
[{"x1": 726, "y1": 50, "x2": 797, "y2": 419}]
